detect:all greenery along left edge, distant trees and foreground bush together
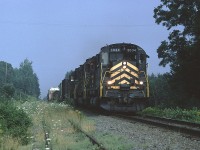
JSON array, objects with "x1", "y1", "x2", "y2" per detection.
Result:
[{"x1": 0, "y1": 59, "x2": 40, "y2": 150}]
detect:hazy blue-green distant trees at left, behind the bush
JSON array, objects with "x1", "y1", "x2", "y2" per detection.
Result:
[{"x1": 0, "y1": 59, "x2": 40, "y2": 98}]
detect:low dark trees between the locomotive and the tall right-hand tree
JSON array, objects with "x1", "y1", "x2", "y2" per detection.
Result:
[{"x1": 149, "y1": 74, "x2": 200, "y2": 109}]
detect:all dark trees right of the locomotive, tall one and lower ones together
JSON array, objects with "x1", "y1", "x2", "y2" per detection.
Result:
[{"x1": 149, "y1": 0, "x2": 200, "y2": 107}]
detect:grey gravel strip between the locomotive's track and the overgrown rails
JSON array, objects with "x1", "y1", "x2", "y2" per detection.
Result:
[{"x1": 88, "y1": 115, "x2": 200, "y2": 150}]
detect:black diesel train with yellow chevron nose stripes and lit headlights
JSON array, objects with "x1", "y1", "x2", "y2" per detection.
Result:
[{"x1": 60, "y1": 43, "x2": 149, "y2": 112}]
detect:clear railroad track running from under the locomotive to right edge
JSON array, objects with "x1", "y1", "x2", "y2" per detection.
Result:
[{"x1": 112, "y1": 114, "x2": 200, "y2": 137}]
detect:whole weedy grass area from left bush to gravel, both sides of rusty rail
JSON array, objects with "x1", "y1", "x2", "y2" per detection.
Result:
[{"x1": 0, "y1": 100, "x2": 133, "y2": 150}]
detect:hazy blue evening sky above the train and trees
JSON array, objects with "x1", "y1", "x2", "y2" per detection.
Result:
[{"x1": 0, "y1": 0, "x2": 169, "y2": 98}]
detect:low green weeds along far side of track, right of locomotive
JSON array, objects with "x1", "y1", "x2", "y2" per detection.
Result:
[{"x1": 140, "y1": 107, "x2": 200, "y2": 123}]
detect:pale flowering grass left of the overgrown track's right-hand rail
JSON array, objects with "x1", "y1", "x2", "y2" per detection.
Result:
[{"x1": 17, "y1": 101, "x2": 98, "y2": 150}]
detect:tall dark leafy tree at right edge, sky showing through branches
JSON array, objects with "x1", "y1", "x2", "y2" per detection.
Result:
[{"x1": 154, "y1": 0, "x2": 200, "y2": 102}]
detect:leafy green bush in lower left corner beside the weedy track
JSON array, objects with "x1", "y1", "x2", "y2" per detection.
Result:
[{"x1": 0, "y1": 101, "x2": 32, "y2": 149}]
